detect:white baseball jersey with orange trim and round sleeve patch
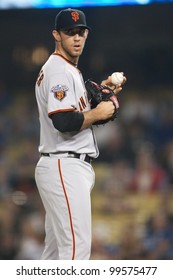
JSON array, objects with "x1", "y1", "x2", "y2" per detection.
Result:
[{"x1": 36, "y1": 53, "x2": 98, "y2": 158}]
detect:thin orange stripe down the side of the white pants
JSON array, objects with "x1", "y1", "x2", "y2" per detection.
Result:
[{"x1": 58, "y1": 159, "x2": 75, "y2": 260}]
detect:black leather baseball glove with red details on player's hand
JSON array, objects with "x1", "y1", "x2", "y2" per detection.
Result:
[{"x1": 85, "y1": 79, "x2": 119, "y2": 125}]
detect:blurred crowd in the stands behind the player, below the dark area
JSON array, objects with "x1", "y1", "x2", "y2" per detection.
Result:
[{"x1": 0, "y1": 78, "x2": 173, "y2": 260}]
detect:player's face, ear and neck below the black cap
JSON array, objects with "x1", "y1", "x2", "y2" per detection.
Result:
[{"x1": 54, "y1": 27, "x2": 88, "y2": 63}]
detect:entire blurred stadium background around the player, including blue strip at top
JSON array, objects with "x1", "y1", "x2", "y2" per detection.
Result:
[{"x1": 0, "y1": 0, "x2": 173, "y2": 260}]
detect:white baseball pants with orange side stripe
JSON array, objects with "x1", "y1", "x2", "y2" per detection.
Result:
[{"x1": 35, "y1": 155, "x2": 95, "y2": 260}]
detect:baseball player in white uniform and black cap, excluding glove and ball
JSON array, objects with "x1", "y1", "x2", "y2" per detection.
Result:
[{"x1": 35, "y1": 9, "x2": 125, "y2": 260}]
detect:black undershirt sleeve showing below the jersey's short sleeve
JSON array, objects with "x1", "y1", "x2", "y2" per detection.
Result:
[{"x1": 50, "y1": 111, "x2": 84, "y2": 132}]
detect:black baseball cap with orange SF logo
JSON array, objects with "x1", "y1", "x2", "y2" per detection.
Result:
[{"x1": 55, "y1": 8, "x2": 91, "y2": 30}]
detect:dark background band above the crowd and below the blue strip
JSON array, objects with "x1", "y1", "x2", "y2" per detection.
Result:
[{"x1": 0, "y1": 4, "x2": 173, "y2": 90}]
